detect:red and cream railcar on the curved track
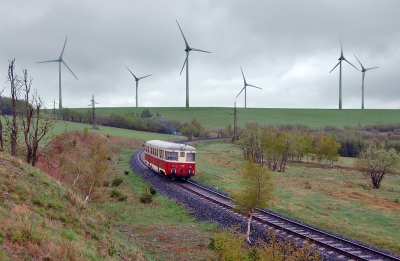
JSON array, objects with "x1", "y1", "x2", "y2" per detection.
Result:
[{"x1": 145, "y1": 140, "x2": 196, "y2": 179}]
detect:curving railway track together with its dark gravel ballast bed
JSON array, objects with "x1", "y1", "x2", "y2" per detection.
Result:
[{"x1": 131, "y1": 149, "x2": 400, "y2": 261}]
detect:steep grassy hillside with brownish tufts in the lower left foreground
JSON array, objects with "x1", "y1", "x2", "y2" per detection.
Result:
[{"x1": 0, "y1": 153, "x2": 140, "y2": 260}]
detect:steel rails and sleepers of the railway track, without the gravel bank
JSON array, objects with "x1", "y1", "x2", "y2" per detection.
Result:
[{"x1": 138, "y1": 148, "x2": 400, "y2": 261}]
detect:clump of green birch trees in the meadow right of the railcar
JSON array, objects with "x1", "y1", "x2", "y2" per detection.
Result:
[{"x1": 236, "y1": 123, "x2": 340, "y2": 172}]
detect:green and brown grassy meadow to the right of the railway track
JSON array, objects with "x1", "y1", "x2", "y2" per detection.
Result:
[{"x1": 193, "y1": 138, "x2": 400, "y2": 254}]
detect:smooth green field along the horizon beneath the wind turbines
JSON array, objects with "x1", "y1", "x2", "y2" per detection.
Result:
[{"x1": 60, "y1": 107, "x2": 400, "y2": 130}]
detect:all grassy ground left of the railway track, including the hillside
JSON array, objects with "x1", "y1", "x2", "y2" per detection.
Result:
[{"x1": 0, "y1": 123, "x2": 216, "y2": 260}]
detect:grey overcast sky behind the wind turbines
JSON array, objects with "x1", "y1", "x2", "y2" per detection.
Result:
[{"x1": 0, "y1": 0, "x2": 400, "y2": 109}]
